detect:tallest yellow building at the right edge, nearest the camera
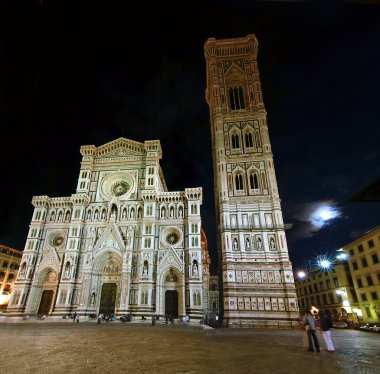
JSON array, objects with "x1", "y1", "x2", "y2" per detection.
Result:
[{"x1": 343, "y1": 226, "x2": 380, "y2": 323}]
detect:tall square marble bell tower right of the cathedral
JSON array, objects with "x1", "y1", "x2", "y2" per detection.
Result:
[{"x1": 204, "y1": 35, "x2": 299, "y2": 327}]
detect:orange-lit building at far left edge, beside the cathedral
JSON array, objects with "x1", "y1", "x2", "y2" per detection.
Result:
[{"x1": 0, "y1": 244, "x2": 22, "y2": 310}]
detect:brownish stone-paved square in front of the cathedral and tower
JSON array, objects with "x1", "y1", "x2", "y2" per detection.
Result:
[{"x1": 0, "y1": 321, "x2": 380, "y2": 374}]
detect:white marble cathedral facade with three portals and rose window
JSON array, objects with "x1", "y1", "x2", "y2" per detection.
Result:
[{"x1": 7, "y1": 138, "x2": 209, "y2": 319}]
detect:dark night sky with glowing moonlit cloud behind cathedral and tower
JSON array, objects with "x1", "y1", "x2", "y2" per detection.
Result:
[{"x1": 0, "y1": 0, "x2": 380, "y2": 270}]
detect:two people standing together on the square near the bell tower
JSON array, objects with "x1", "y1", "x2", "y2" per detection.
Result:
[{"x1": 305, "y1": 309, "x2": 335, "y2": 352}]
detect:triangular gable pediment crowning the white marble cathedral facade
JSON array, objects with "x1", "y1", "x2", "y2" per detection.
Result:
[{"x1": 96, "y1": 138, "x2": 146, "y2": 158}]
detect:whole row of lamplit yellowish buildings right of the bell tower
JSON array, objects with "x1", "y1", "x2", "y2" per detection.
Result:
[{"x1": 295, "y1": 227, "x2": 380, "y2": 326}]
